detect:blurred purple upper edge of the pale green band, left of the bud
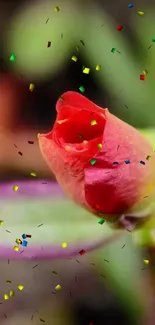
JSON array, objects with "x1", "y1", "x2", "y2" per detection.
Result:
[{"x1": 0, "y1": 180, "x2": 64, "y2": 199}]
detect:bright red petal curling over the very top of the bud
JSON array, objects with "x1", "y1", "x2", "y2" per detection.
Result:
[{"x1": 56, "y1": 91, "x2": 103, "y2": 112}]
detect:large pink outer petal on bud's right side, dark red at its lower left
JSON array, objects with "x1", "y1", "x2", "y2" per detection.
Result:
[{"x1": 85, "y1": 113, "x2": 152, "y2": 214}]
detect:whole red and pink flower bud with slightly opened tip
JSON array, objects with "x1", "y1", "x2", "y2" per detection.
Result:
[{"x1": 38, "y1": 91, "x2": 155, "y2": 230}]
